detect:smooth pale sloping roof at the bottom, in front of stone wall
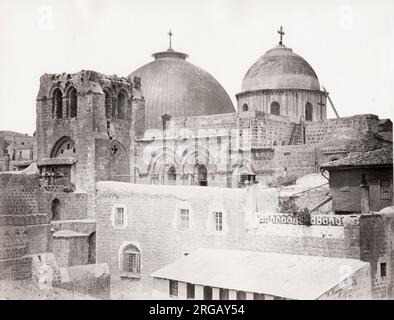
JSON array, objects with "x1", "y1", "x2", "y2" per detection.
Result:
[{"x1": 151, "y1": 248, "x2": 368, "y2": 299}]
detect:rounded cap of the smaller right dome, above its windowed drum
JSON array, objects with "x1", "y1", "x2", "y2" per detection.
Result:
[{"x1": 242, "y1": 44, "x2": 320, "y2": 92}]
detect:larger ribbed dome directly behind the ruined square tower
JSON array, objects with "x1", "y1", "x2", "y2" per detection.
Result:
[{"x1": 129, "y1": 49, "x2": 235, "y2": 129}]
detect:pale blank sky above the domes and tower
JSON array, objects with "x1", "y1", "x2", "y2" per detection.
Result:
[{"x1": 0, "y1": 0, "x2": 394, "y2": 134}]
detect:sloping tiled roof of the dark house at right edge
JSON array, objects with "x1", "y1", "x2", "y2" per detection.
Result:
[{"x1": 321, "y1": 147, "x2": 393, "y2": 169}]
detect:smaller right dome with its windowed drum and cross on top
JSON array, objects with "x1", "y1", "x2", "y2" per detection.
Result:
[{"x1": 236, "y1": 27, "x2": 327, "y2": 122}]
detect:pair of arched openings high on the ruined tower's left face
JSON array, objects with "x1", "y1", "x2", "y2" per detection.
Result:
[{"x1": 52, "y1": 87, "x2": 78, "y2": 119}]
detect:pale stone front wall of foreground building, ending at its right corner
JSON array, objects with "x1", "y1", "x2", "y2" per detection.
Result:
[{"x1": 97, "y1": 182, "x2": 374, "y2": 297}]
